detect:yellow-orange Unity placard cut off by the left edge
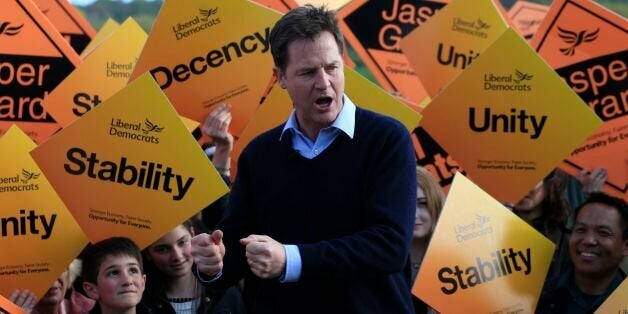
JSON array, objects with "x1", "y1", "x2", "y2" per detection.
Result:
[{"x1": 0, "y1": 126, "x2": 87, "y2": 297}]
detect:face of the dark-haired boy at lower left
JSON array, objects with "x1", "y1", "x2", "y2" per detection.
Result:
[{"x1": 83, "y1": 255, "x2": 146, "y2": 312}]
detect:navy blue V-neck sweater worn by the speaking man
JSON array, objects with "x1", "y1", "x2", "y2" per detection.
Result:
[{"x1": 209, "y1": 108, "x2": 417, "y2": 313}]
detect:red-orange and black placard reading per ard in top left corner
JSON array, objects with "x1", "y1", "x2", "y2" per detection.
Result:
[{"x1": 0, "y1": 0, "x2": 81, "y2": 143}]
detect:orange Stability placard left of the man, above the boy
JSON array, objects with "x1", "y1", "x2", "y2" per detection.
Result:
[{"x1": 31, "y1": 74, "x2": 228, "y2": 248}]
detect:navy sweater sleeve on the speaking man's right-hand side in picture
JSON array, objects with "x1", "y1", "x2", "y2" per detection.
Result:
[{"x1": 298, "y1": 120, "x2": 417, "y2": 282}]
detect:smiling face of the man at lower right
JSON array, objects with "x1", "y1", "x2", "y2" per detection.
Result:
[{"x1": 569, "y1": 203, "x2": 628, "y2": 276}]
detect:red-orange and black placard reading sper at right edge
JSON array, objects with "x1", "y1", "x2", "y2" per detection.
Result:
[{"x1": 532, "y1": 0, "x2": 628, "y2": 200}]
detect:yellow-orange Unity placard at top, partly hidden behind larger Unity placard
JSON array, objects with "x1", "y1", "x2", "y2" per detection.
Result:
[{"x1": 401, "y1": 0, "x2": 508, "y2": 98}]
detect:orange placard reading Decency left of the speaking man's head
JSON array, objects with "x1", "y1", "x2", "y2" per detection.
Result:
[{"x1": 131, "y1": 0, "x2": 280, "y2": 138}]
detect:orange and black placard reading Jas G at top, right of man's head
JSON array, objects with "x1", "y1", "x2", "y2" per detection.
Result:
[{"x1": 338, "y1": 0, "x2": 445, "y2": 104}]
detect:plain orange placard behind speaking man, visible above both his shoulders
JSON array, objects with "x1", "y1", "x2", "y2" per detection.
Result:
[{"x1": 231, "y1": 67, "x2": 421, "y2": 178}]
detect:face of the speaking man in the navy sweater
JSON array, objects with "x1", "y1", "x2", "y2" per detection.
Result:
[{"x1": 274, "y1": 31, "x2": 345, "y2": 138}]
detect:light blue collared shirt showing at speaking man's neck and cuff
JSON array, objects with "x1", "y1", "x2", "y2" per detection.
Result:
[{"x1": 279, "y1": 95, "x2": 355, "y2": 282}]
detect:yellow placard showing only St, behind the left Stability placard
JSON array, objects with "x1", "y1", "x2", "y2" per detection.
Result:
[{"x1": 43, "y1": 18, "x2": 147, "y2": 127}]
